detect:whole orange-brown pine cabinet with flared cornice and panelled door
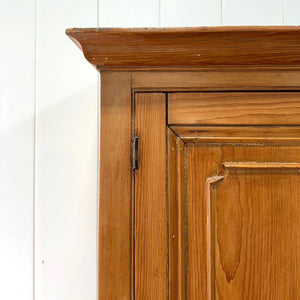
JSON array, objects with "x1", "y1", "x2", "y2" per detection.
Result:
[{"x1": 67, "y1": 27, "x2": 300, "y2": 300}]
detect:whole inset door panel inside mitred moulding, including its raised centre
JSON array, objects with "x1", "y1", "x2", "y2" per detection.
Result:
[{"x1": 186, "y1": 143, "x2": 300, "y2": 300}]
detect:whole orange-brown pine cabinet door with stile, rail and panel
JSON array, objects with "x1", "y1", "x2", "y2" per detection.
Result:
[{"x1": 133, "y1": 92, "x2": 300, "y2": 300}]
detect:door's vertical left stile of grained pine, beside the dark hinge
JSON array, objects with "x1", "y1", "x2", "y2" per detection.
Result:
[{"x1": 135, "y1": 93, "x2": 168, "y2": 300}]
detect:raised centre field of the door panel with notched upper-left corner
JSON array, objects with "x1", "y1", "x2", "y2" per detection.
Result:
[{"x1": 206, "y1": 162, "x2": 300, "y2": 299}]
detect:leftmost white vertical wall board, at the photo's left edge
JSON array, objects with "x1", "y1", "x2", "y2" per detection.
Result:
[{"x1": 0, "y1": 0, "x2": 35, "y2": 300}]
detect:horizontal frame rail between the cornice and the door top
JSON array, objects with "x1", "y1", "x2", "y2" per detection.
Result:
[{"x1": 132, "y1": 66, "x2": 300, "y2": 91}]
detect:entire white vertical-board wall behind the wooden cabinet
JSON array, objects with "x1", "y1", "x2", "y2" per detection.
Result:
[{"x1": 0, "y1": 0, "x2": 300, "y2": 300}]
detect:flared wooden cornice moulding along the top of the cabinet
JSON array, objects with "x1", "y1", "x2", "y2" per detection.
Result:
[{"x1": 66, "y1": 26, "x2": 300, "y2": 70}]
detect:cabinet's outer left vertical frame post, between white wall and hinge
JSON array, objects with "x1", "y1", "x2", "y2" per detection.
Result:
[{"x1": 99, "y1": 72, "x2": 131, "y2": 300}]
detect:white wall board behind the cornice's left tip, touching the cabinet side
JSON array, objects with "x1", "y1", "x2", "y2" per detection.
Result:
[{"x1": 35, "y1": 0, "x2": 98, "y2": 300}]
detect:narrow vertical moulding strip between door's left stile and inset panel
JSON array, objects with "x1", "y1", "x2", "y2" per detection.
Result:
[{"x1": 168, "y1": 129, "x2": 186, "y2": 300}]
